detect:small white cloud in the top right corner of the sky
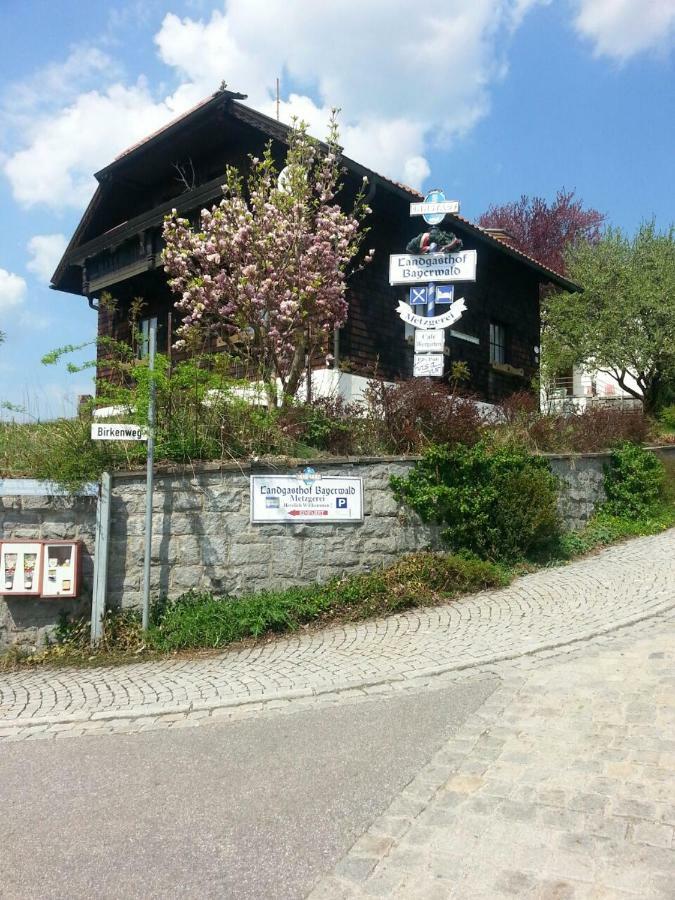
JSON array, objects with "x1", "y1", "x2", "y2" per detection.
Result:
[{"x1": 574, "y1": 0, "x2": 675, "y2": 61}]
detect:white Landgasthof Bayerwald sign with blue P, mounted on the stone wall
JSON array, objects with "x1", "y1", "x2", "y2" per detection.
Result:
[{"x1": 251, "y1": 472, "x2": 363, "y2": 524}]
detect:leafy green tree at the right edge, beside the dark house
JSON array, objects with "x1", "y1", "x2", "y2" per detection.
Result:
[{"x1": 543, "y1": 222, "x2": 675, "y2": 413}]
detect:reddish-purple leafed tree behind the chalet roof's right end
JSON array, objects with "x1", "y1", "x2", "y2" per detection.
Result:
[{"x1": 478, "y1": 188, "x2": 605, "y2": 273}]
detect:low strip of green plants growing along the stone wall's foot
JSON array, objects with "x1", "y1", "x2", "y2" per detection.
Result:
[{"x1": 5, "y1": 552, "x2": 512, "y2": 669}]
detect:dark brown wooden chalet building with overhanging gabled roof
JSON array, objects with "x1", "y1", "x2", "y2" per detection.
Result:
[{"x1": 52, "y1": 90, "x2": 575, "y2": 401}]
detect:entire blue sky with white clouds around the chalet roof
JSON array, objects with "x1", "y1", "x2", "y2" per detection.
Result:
[{"x1": 0, "y1": 0, "x2": 675, "y2": 417}]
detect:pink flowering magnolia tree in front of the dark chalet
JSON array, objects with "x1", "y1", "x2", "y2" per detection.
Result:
[{"x1": 164, "y1": 114, "x2": 373, "y2": 402}]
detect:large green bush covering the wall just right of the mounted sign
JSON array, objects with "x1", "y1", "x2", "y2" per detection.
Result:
[{"x1": 391, "y1": 441, "x2": 559, "y2": 561}]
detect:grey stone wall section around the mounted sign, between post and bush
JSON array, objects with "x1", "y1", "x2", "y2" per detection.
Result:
[{"x1": 108, "y1": 459, "x2": 441, "y2": 606}]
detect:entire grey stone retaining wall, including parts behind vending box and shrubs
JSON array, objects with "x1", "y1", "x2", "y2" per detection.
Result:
[{"x1": 0, "y1": 446, "x2": 675, "y2": 648}]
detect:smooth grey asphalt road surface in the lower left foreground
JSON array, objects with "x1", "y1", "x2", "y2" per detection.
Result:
[{"x1": 0, "y1": 677, "x2": 497, "y2": 900}]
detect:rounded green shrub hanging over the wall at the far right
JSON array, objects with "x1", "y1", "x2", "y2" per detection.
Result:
[{"x1": 602, "y1": 444, "x2": 665, "y2": 516}]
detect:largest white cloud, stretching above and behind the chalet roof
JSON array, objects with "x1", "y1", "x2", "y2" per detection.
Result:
[{"x1": 2, "y1": 0, "x2": 547, "y2": 209}]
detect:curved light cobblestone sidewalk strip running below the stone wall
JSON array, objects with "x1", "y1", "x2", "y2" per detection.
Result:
[{"x1": 0, "y1": 530, "x2": 675, "y2": 741}]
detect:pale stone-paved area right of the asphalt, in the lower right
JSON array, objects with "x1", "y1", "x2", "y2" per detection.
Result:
[{"x1": 310, "y1": 611, "x2": 675, "y2": 900}]
